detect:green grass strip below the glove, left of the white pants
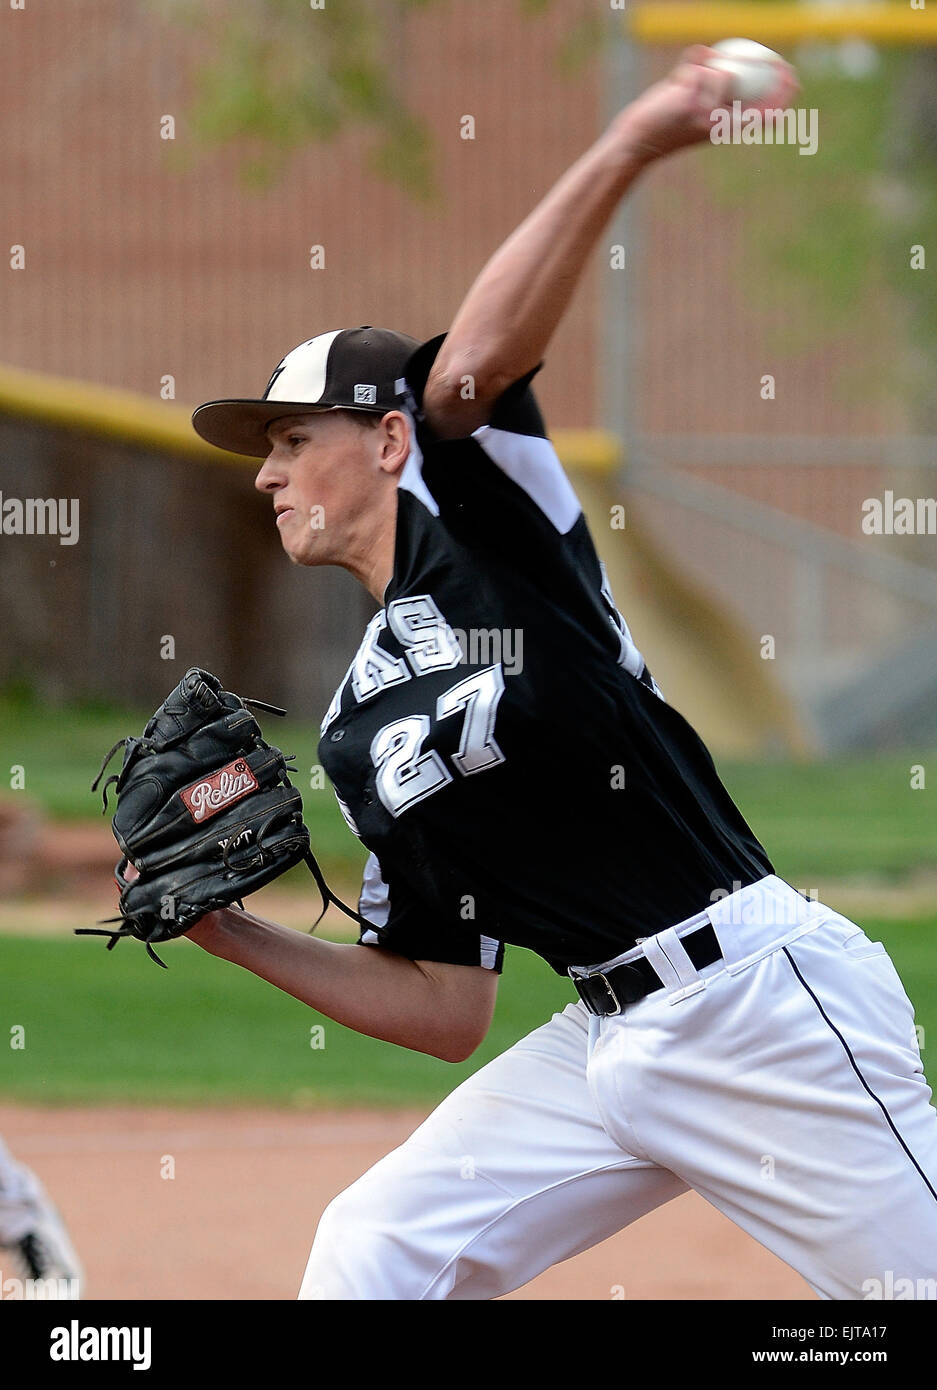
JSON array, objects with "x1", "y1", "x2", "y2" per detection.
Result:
[{"x1": 0, "y1": 937, "x2": 574, "y2": 1106}]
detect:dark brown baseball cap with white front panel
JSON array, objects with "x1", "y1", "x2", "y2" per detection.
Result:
[{"x1": 192, "y1": 324, "x2": 420, "y2": 459}]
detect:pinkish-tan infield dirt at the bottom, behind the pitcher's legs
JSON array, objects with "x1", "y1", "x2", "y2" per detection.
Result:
[{"x1": 0, "y1": 1104, "x2": 813, "y2": 1301}]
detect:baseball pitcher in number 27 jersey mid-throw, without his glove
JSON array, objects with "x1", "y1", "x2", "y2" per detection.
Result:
[{"x1": 140, "y1": 49, "x2": 937, "y2": 1300}]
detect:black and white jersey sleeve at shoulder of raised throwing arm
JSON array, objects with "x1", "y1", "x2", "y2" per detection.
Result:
[{"x1": 398, "y1": 334, "x2": 582, "y2": 560}]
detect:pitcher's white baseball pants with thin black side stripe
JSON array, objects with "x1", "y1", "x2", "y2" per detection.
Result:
[{"x1": 299, "y1": 876, "x2": 937, "y2": 1300}]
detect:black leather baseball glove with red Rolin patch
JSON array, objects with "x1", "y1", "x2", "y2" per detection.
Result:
[{"x1": 76, "y1": 667, "x2": 357, "y2": 969}]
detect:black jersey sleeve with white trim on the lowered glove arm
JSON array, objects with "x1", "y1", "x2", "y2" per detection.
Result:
[{"x1": 357, "y1": 852, "x2": 505, "y2": 974}]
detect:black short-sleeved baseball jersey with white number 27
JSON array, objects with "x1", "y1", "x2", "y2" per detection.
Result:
[{"x1": 318, "y1": 335, "x2": 773, "y2": 972}]
